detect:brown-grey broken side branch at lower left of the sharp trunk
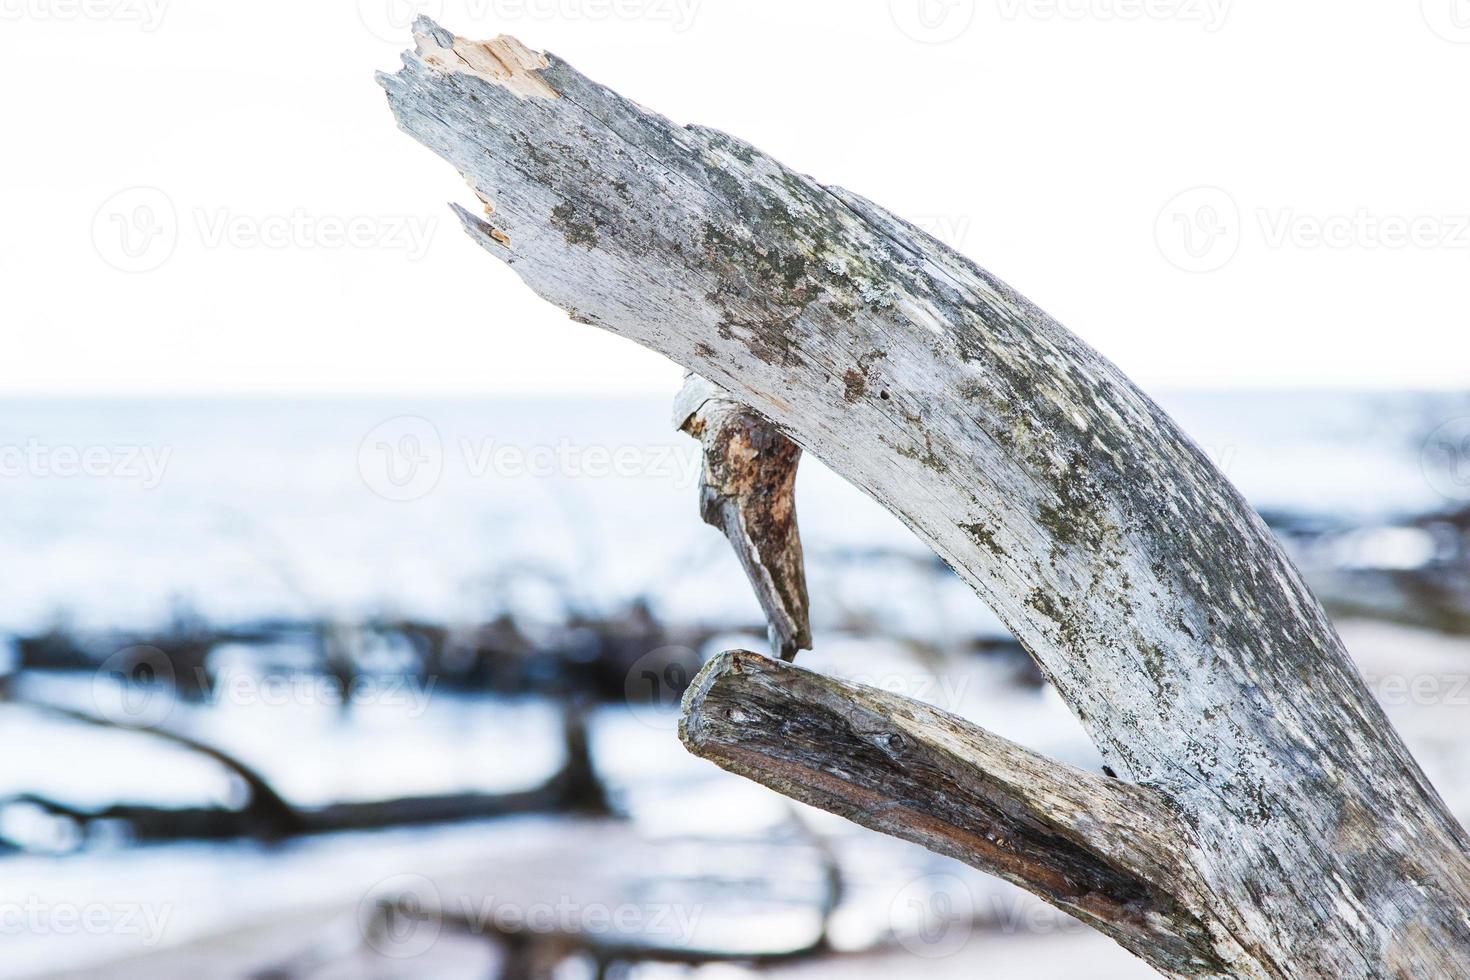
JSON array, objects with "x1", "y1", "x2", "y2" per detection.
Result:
[{"x1": 679, "y1": 652, "x2": 1241, "y2": 976}]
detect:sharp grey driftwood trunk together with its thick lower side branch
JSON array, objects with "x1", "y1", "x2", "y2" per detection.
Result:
[{"x1": 381, "y1": 21, "x2": 1470, "y2": 979}]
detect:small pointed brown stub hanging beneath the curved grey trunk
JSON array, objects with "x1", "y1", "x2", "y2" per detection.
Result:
[{"x1": 673, "y1": 376, "x2": 811, "y2": 660}]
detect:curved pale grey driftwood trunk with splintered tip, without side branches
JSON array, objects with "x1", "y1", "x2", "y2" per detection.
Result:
[{"x1": 381, "y1": 21, "x2": 1470, "y2": 977}]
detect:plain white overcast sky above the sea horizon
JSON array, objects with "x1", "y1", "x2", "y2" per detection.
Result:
[{"x1": 0, "y1": 0, "x2": 1470, "y2": 395}]
